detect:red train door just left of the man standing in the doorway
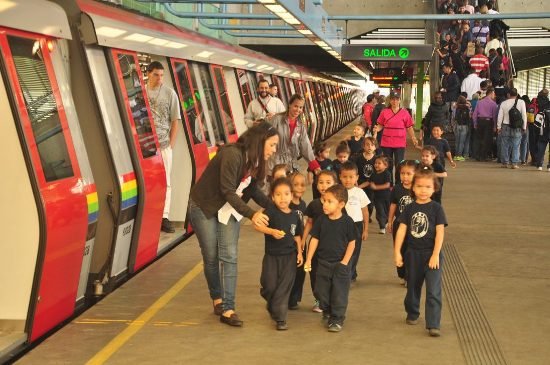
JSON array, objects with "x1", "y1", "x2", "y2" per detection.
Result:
[{"x1": 109, "y1": 49, "x2": 166, "y2": 272}]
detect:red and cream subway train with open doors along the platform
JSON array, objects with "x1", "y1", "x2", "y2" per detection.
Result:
[{"x1": 0, "y1": 0, "x2": 362, "y2": 362}]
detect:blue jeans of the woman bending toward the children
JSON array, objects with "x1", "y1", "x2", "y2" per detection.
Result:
[{"x1": 189, "y1": 200, "x2": 240, "y2": 311}]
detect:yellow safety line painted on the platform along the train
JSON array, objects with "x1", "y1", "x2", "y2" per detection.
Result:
[{"x1": 86, "y1": 262, "x2": 202, "y2": 365}]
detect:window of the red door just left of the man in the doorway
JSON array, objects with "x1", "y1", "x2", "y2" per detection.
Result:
[{"x1": 116, "y1": 53, "x2": 157, "y2": 158}]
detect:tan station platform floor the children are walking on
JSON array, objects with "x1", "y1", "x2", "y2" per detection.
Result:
[{"x1": 16, "y1": 125, "x2": 550, "y2": 365}]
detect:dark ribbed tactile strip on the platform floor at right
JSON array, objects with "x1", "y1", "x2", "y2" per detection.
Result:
[{"x1": 443, "y1": 244, "x2": 507, "y2": 365}]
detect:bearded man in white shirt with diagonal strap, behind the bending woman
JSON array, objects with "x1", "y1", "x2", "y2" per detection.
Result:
[{"x1": 244, "y1": 80, "x2": 286, "y2": 128}]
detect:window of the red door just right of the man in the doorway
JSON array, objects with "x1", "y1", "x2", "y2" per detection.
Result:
[{"x1": 174, "y1": 62, "x2": 204, "y2": 144}]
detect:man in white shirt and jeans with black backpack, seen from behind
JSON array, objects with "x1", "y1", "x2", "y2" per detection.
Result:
[{"x1": 497, "y1": 88, "x2": 527, "y2": 169}]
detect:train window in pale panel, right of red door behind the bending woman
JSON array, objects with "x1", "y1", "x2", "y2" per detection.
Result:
[{"x1": 193, "y1": 63, "x2": 226, "y2": 144}]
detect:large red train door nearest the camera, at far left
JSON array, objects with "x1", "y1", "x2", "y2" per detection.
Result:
[{"x1": 0, "y1": 28, "x2": 89, "y2": 341}]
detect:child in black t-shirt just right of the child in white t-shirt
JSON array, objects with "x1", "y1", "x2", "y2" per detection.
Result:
[{"x1": 368, "y1": 155, "x2": 391, "y2": 234}]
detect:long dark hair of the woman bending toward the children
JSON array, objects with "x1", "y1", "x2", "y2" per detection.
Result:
[{"x1": 237, "y1": 122, "x2": 277, "y2": 184}]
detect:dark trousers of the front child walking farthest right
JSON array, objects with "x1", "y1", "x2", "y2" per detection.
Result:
[{"x1": 404, "y1": 248, "x2": 443, "y2": 329}]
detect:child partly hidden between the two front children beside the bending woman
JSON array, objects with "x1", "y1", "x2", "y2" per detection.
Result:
[{"x1": 288, "y1": 172, "x2": 306, "y2": 310}]
